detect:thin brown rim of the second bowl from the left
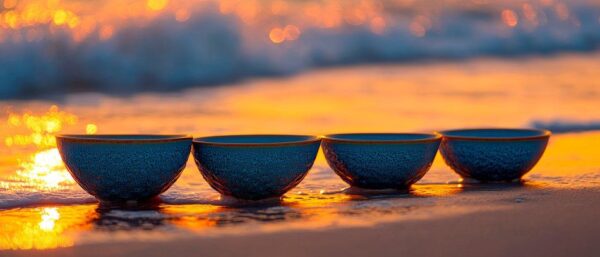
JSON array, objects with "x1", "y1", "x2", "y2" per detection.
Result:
[{"x1": 192, "y1": 134, "x2": 321, "y2": 147}]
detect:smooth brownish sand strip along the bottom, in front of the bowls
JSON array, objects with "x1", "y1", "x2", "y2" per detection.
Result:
[{"x1": 0, "y1": 188, "x2": 600, "y2": 257}]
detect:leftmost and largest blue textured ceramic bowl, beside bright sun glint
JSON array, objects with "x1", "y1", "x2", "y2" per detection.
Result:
[{"x1": 56, "y1": 135, "x2": 192, "y2": 201}]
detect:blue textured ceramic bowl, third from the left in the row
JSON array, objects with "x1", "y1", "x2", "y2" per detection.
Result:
[{"x1": 323, "y1": 133, "x2": 441, "y2": 189}]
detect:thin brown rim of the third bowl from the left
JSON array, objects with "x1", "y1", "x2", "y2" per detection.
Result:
[{"x1": 323, "y1": 132, "x2": 442, "y2": 144}]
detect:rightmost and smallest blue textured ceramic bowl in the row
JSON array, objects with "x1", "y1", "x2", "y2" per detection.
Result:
[{"x1": 440, "y1": 129, "x2": 550, "y2": 182}]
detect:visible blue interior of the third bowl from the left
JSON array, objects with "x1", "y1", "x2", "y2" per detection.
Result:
[{"x1": 325, "y1": 133, "x2": 439, "y2": 142}]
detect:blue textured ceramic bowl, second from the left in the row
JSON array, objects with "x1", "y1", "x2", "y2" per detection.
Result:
[{"x1": 193, "y1": 135, "x2": 321, "y2": 200}]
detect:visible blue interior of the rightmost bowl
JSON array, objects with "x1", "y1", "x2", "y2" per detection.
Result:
[{"x1": 441, "y1": 129, "x2": 548, "y2": 139}]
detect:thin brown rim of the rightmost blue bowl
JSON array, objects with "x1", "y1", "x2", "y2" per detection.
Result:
[{"x1": 438, "y1": 128, "x2": 552, "y2": 142}]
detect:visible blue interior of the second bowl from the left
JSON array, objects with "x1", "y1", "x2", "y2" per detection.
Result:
[{"x1": 194, "y1": 135, "x2": 317, "y2": 145}]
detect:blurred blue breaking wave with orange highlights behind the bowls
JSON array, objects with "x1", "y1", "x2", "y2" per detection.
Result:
[{"x1": 0, "y1": 0, "x2": 600, "y2": 99}]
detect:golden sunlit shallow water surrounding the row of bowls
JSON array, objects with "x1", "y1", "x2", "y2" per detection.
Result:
[{"x1": 0, "y1": 54, "x2": 600, "y2": 249}]
